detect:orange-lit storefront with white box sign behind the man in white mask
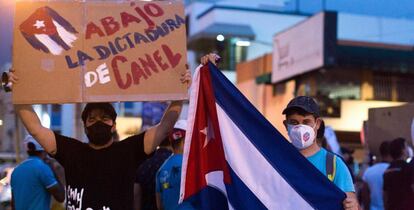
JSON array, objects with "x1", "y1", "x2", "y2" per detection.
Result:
[{"x1": 237, "y1": 12, "x2": 414, "y2": 156}]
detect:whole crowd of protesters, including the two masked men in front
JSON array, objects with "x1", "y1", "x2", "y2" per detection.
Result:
[{"x1": 4, "y1": 54, "x2": 414, "y2": 210}]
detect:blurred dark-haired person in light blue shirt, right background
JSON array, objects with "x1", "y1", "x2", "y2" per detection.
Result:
[{"x1": 361, "y1": 141, "x2": 392, "y2": 210}]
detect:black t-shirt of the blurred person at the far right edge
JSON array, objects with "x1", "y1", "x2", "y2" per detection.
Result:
[{"x1": 383, "y1": 160, "x2": 414, "y2": 210}]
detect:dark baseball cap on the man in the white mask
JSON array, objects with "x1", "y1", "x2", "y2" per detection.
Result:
[{"x1": 282, "y1": 96, "x2": 320, "y2": 117}]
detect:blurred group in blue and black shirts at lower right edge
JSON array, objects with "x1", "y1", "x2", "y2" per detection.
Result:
[{"x1": 359, "y1": 137, "x2": 414, "y2": 210}]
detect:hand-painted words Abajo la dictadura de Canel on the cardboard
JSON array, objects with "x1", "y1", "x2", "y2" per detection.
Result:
[{"x1": 65, "y1": 3, "x2": 185, "y2": 89}]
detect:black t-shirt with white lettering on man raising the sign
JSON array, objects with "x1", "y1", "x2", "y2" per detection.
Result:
[{"x1": 55, "y1": 133, "x2": 147, "y2": 210}]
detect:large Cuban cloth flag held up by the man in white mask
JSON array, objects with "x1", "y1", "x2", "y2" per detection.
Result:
[{"x1": 180, "y1": 63, "x2": 345, "y2": 210}]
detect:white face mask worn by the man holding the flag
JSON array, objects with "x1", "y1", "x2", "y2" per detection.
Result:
[{"x1": 288, "y1": 124, "x2": 315, "y2": 150}]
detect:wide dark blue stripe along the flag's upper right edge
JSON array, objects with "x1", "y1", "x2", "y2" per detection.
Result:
[{"x1": 209, "y1": 63, "x2": 346, "y2": 210}]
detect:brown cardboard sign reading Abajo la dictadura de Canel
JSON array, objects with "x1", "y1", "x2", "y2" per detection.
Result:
[{"x1": 13, "y1": 0, "x2": 187, "y2": 104}]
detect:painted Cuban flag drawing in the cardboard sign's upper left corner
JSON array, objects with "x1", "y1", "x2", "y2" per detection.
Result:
[{"x1": 19, "y1": 6, "x2": 78, "y2": 55}]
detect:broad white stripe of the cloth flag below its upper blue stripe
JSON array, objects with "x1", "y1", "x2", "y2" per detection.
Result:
[{"x1": 216, "y1": 104, "x2": 313, "y2": 210}]
